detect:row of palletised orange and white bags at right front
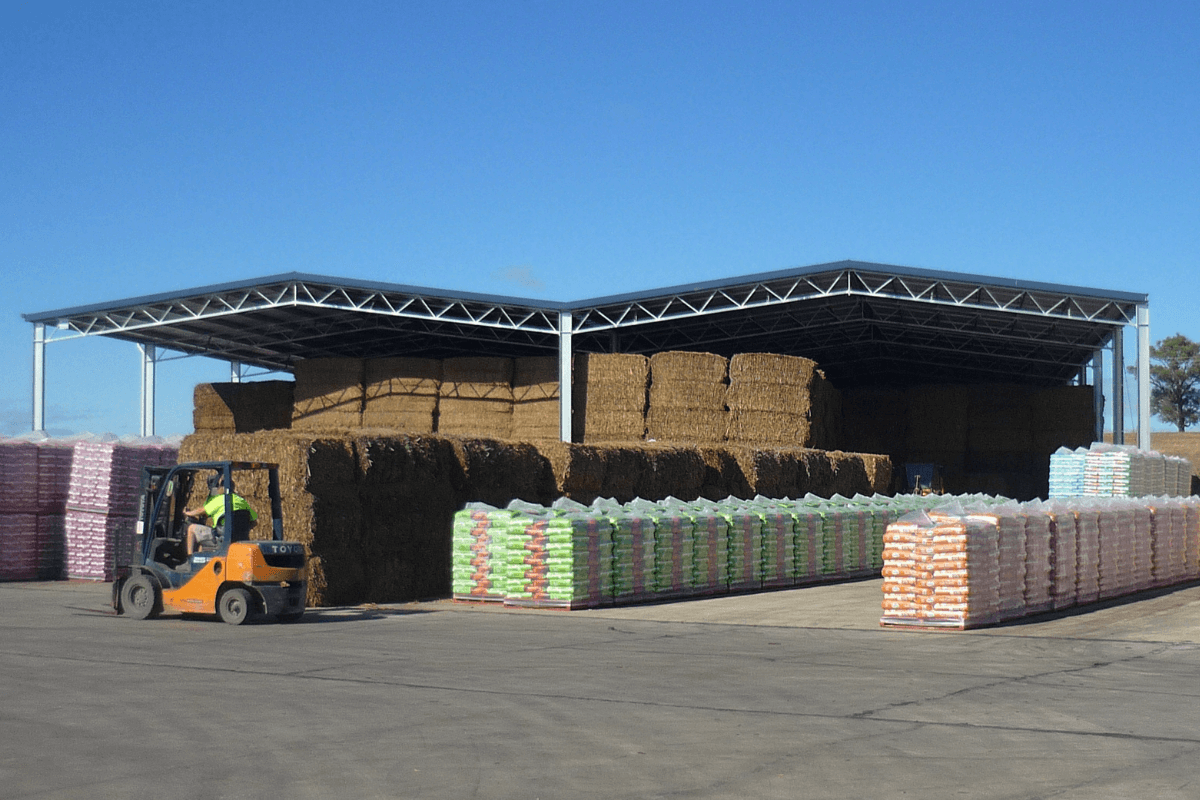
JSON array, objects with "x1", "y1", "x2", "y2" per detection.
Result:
[{"x1": 880, "y1": 497, "x2": 1200, "y2": 628}]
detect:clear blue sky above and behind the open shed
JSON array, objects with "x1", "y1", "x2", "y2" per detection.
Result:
[{"x1": 0, "y1": 0, "x2": 1200, "y2": 435}]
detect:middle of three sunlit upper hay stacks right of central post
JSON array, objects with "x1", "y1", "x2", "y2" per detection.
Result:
[{"x1": 646, "y1": 351, "x2": 728, "y2": 441}]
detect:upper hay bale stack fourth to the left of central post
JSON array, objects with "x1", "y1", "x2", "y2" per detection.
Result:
[{"x1": 292, "y1": 359, "x2": 364, "y2": 431}]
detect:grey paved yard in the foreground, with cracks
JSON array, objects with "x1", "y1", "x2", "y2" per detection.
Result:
[{"x1": 0, "y1": 581, "x2": 1200, "y2": 800}]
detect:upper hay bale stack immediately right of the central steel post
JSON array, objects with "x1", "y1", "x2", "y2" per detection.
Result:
[{"x1": 571, "y1": 353, "x2": 650, "y2": 444}]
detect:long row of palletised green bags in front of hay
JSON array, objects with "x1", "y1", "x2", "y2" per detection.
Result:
[{"x1": 451, "y1": 495, "x2": 907, "y2": 608}]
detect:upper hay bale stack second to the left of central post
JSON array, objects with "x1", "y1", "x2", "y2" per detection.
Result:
[{"x1": 438, "y1": 356, "x2": 512, "y2": 439}]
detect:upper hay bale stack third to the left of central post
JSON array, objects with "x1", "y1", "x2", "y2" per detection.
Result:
[{"x1": 362, "y1": 357, "x2": 442, "y2": 433}]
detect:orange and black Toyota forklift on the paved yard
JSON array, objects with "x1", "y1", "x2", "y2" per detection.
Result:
[{"x1": 113, "y1": 461, "x2": 308, "y2": 625}]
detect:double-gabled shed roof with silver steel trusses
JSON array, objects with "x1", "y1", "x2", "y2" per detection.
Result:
[{"x1": 24, "y1": 261, "x2": 1147, "y2": 387}]
